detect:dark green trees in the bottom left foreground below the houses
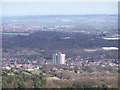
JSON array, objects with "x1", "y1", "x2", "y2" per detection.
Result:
[{"x1": 2, "y1": 70, "x2": 46, "y2": 88}]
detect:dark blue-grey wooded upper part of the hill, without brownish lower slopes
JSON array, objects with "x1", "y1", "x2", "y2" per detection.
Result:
[{"x1": 3, "y1": 31, "x2": 117, "y2": 50}]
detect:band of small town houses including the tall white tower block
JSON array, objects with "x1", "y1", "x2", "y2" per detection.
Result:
[{"x1": 2, "y1": 52, "x2": 119, "y2": 71}]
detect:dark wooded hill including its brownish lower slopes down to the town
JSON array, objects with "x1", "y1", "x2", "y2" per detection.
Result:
[{"x1": 2, "y1": 31, "x2": 118, "y2": 60}]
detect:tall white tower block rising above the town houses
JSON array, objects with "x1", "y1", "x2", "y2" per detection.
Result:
[{"x1": 53, "y1": 52, "x2": 66, "y2": 64}]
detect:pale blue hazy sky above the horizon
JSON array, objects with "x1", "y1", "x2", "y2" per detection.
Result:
[{"x1": 2, "y1": 2, "x2": 118, "y2": 16}]
